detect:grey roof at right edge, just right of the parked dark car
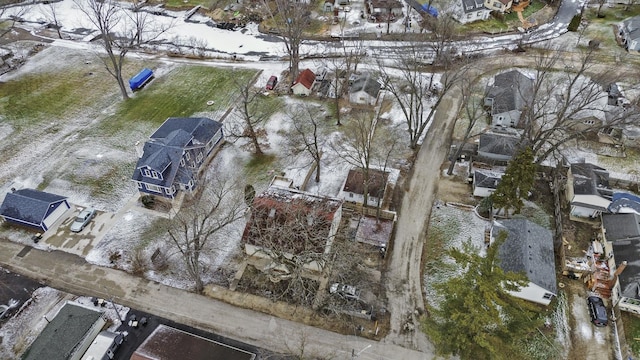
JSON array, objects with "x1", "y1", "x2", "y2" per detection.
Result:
[{"x1": 612, "y1": 239, "x2": 640, "y2": 300}]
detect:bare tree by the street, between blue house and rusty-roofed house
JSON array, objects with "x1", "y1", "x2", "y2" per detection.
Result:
[{"x1": 167, "y1": 178, "x2": 245, "y2": 293}]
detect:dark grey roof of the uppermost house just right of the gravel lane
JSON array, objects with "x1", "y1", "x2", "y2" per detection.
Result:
[{"x1": 486, "y1": 70, "x2": 533, "y2": 114}]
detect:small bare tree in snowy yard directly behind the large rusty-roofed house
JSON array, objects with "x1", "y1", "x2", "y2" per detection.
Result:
[{"x1": 288, "y1": 103, "x2": 325, "y2": 182}]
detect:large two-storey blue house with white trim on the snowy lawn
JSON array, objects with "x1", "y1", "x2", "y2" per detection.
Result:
[{"x1": 131, "y1": 118, "x2": 223, "y2": 199}]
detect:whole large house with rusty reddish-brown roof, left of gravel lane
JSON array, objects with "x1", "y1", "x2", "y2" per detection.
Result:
[{"x1": 242, "y1": 180, "x2": 342, "y2": 274}]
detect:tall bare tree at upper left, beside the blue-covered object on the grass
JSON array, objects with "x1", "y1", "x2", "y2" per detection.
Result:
[{"x1": 74, "y1": 0, "x2": 172, "y2": 99}]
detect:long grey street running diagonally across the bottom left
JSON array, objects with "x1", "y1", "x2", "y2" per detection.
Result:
[{"x1": 0, "y1": 240, "x2": 434, "y2": 360}]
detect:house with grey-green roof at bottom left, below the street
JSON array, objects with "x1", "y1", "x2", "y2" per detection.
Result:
[{"x1": 22, "y1": 302, "x2": 107, "y2": 360}]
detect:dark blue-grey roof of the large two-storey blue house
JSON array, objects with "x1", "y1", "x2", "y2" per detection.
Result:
[{"x1": 131, "y1": 118, "x2": 222, "y2": 187}]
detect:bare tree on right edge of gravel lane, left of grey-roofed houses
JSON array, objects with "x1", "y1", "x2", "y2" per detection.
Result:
[{"x1": 447, "y1": 78, "x2": 486, "y2": 175}]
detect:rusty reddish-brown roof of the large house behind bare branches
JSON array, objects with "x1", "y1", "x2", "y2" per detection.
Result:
[{"x1": 242, "y1": 186, "x2": 342, "y2": 254}]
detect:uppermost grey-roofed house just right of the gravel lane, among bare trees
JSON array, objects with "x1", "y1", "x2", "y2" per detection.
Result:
[{"x1": 484, "y1": 69, "x2": 533, "y2": 127}]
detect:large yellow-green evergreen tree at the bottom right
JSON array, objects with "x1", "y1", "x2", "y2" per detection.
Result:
[{"x1": 424, "y1": 232, "x2": 542, "y2": 360}]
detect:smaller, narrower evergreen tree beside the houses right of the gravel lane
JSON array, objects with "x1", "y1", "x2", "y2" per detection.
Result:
[{"x1": 491, "y1": 147, "x2": 536, "y2": 215}]
